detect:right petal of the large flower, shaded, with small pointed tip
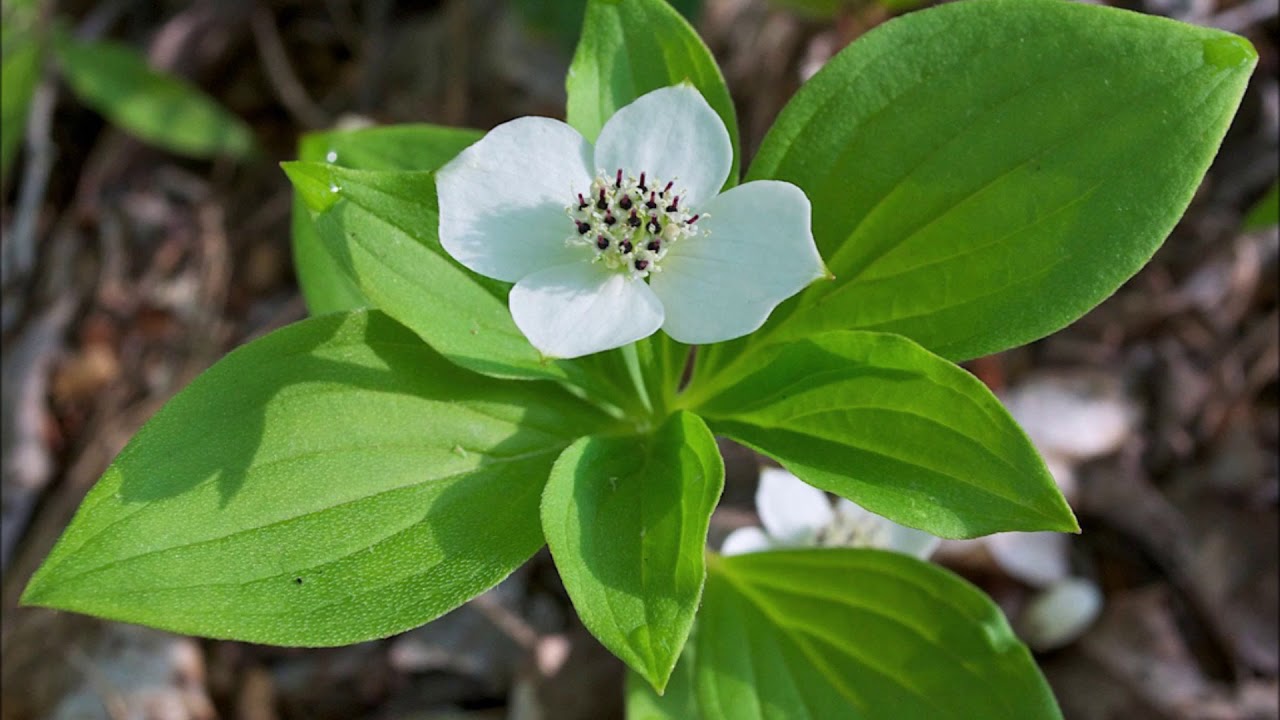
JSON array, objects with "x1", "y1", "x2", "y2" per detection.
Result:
[{"x1": 649, "y1": 181, "x2": 826, "y2": 345}]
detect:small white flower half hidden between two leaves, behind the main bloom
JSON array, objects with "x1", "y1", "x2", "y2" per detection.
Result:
[{"x1": 721, "y1": 468, "x2": 940, "y2": 560}]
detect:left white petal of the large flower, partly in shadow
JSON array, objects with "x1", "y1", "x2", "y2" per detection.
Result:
[{"x1": 435, "y1": 118, "x2": 591, "y2": 282}]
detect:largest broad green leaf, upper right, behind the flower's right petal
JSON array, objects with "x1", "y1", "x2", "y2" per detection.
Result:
[{"x1": 732, "y1": 0, "x2": 1257, "y2": 360}]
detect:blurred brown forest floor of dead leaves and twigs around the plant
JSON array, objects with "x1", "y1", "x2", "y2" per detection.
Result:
[{"x1": 0, "y1": 0, "x2": 1280, "y2": 720}]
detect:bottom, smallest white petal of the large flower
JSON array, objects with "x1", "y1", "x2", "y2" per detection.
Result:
[{"x1": 508, "y1": 260, "x2": 662, "y2": 357}]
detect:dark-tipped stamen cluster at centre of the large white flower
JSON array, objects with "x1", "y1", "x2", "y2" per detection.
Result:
[{"x1": 564, "y1": 169, "x2": 700, "y2": 279}]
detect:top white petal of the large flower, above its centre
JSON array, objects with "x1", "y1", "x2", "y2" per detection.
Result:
[{"x1": 591, "y1": 85, "x2": 733, "y2": 208}]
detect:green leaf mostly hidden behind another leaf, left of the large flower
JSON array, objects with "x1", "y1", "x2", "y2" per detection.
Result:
[{"x1": 293, "y1": 124, "x2": 481, "y2": 315}]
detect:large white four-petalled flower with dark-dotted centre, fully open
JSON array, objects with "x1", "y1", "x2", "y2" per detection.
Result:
[{"x1": 436, "y1": 85, "x2": 826, "y2": 357}]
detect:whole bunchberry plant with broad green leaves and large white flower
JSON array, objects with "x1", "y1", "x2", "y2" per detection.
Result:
[{"x1": 23, "y1": 0, "x2": 1256, "y2": 720}]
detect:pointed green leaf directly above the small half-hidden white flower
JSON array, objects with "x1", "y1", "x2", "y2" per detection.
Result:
[{"x1": 686, "y1": 331, "x2": 1079, "y2": 538}]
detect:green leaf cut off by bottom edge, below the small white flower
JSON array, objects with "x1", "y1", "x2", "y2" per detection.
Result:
[{"x1": 695, "y1": 550, "x2": 1061, "y2": 720}]
